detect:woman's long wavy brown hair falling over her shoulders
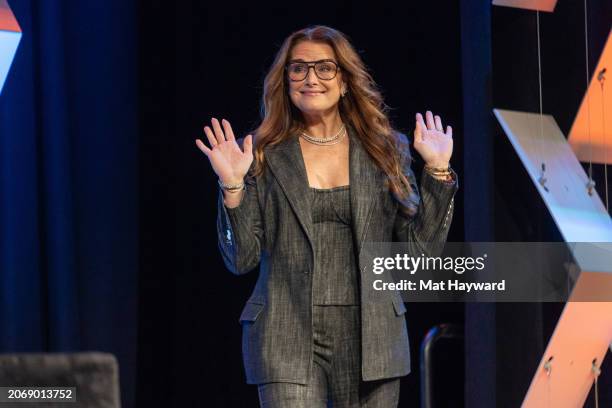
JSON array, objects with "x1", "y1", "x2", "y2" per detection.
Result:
[{"x1": 253, "y1": 25, "x2": 417, "y2": 215}]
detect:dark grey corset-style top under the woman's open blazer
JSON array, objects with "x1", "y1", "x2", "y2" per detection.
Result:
[{"x1": 310, "y1": 185, "x2": 359, "y2": 305}]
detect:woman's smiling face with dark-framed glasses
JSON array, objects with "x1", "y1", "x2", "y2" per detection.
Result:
[{"x1": 288, "y1": 41, "x2": 346, "y2": 115}]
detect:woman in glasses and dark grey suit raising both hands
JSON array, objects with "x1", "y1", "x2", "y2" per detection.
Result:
[{"x1": 196, "y1": 26, "x2": 457, "y2": 408}]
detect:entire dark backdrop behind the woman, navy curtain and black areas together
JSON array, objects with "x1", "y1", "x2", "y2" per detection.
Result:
[{"x1": 0, "y1": 0, "x2": 612, "y2": 408}]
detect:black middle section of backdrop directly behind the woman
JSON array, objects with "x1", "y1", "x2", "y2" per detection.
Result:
[{"x1": 138, "y1": 1, "x2": 464, "y2": 407}]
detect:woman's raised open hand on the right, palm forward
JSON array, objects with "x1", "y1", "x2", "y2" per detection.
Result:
[{"x1": 414, "y1": 111, "x2": 453, "y2": 168}]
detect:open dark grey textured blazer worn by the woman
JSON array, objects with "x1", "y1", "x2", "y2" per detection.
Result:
[{"x1": 217, "y1": 129, "x2": 458, "y2": 384}]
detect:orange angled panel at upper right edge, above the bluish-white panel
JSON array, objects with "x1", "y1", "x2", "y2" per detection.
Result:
[{"x1": 569, "y1": 31, "x2": 612, "y2": 164}]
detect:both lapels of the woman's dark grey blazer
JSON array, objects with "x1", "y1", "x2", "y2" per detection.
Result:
[{"x1": 265, "y1": 126, "x2": 384, "y2": 253}]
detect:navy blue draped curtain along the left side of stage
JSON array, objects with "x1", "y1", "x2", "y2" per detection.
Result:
[{"x1": 0, "y1": 0, "x2": 138, "y2": 407}]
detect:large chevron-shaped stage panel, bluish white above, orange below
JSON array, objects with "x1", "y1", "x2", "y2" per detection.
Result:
[{"x1": 493, "y1": 109, "x2": 612, "y2": 408}]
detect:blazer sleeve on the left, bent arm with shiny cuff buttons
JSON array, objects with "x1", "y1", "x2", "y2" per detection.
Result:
[{"x1": 217, "y1": 155, "x2": 264, "y2": 275}]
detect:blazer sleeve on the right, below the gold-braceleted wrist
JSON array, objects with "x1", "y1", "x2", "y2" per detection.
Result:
[{"x1": 393, "y1": 133, "x2": 459, "y2": 256}]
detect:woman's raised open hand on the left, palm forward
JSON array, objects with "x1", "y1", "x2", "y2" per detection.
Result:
[{"x1": 196, "y1": 118, "x2": 253, "y2": 184}]
